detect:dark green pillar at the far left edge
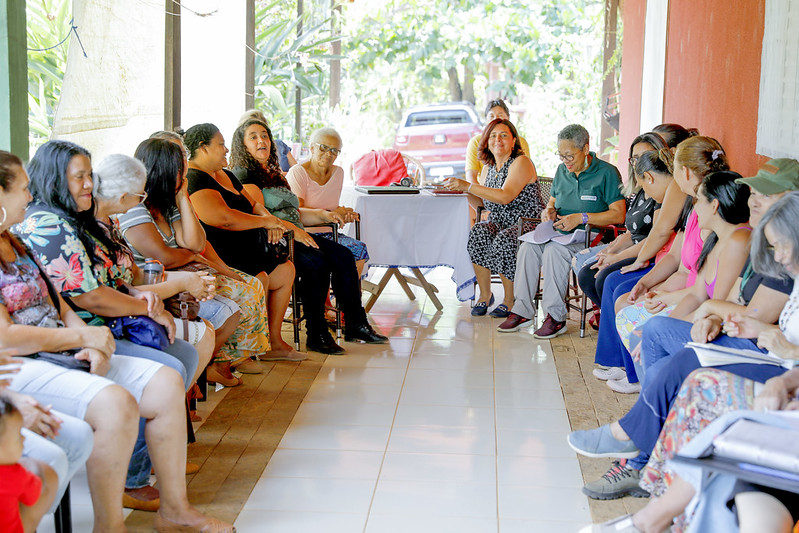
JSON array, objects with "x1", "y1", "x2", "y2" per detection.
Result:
[{"x1": 0, "y1": 0, "x2": 30, "y2": 161}]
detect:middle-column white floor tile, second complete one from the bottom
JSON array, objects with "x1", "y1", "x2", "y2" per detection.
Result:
[{"x1": 380, "y1": 452, "x2": 497, "y2": 484}]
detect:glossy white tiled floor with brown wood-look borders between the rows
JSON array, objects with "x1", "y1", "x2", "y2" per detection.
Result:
[{"x1": 40, "y1": 268, "x2": 639, "y2": 533}]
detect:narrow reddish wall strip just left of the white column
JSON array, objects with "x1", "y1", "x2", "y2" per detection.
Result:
[{"x1": 619, "y1": 0, "x2": 646, "y2": 181}]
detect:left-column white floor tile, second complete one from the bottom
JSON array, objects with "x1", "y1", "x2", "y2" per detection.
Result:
[{"x1": 262, "y1": 448, "x2": 383, "y2": 480}]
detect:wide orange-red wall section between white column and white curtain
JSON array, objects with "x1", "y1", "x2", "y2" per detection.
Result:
[{"x1": 664, "y1": 0, "x2": 766, "y2": 176}]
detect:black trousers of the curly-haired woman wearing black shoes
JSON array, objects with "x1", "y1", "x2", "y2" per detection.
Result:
[{"x1": 294, "y1": 234, "x2": 366, "y2": 334}]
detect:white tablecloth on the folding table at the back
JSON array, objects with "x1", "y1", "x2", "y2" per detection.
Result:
[{"x1": 341, "y1": 187, "x2": 475, "y2": 301}]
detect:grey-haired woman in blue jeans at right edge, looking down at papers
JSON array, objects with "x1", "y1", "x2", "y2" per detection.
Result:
[{"x1": 569, "y1": 188, "x2": 799, "y2": 498}]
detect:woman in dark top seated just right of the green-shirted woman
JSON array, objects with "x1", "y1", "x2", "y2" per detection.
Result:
[{"x1": 574, "y1": 133, "x2": 674, "y2": 329}]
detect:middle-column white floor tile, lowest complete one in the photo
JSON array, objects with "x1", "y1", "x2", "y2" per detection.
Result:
[{"x1": 370, "y1": 480, "x2": 496, "y2": 518}]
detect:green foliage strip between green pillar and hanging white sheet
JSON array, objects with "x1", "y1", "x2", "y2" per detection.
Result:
[{"x1": 26, "y1": 0, "x2": 72, "y2": 150}]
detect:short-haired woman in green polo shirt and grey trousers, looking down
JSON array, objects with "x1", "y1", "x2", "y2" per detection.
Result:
[{"x1": 498, "y1": 124, "x2": 626, "y2": 339}]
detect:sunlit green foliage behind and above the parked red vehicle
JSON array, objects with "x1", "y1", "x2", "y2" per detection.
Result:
[{"x1": 344, "y1": 0, "x2": 604, "y2": 171}]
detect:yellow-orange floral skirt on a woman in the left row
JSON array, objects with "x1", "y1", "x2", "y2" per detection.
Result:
[{"x1": 214, "y1": 269, "x2": 269, "y2": 363}]
